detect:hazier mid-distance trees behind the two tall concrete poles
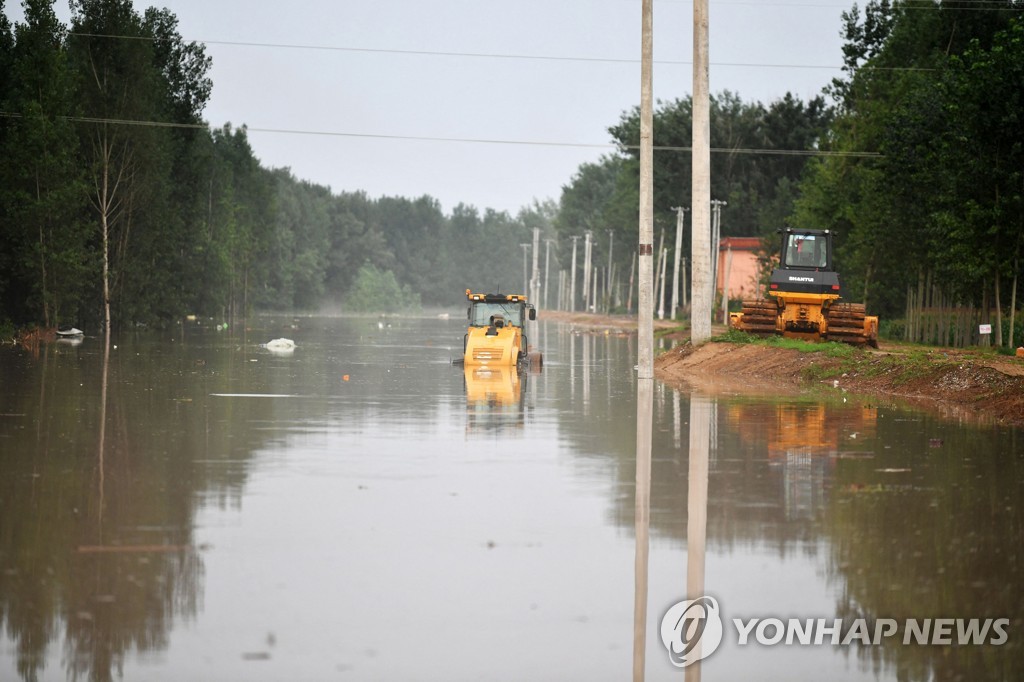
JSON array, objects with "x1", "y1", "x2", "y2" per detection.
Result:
[{"x1": 554, "y1": 92, "x2": 833, "y2": 315}]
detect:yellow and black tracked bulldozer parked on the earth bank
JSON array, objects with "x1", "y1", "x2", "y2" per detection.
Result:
[{"x1": 729, "y1": 227, "x2": 879, "y2": 348}]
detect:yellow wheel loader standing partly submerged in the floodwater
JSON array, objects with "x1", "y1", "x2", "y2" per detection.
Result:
[{"x1": 463, "y1": 289, "x2": 537, "y2": 367}]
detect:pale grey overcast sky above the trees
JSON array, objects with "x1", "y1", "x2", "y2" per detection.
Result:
[{"x1": 6, "y1": 0, "x2": 853, "y2": 215}]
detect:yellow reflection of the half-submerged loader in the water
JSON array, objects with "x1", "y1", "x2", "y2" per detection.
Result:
[{"x1": 463, "y1": 365, "x2": 526, "y2": 433}]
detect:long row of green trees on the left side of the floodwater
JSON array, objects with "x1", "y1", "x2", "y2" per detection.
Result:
[{"x1": 0, "y1": 0, "x2": 554, "y2": 329}]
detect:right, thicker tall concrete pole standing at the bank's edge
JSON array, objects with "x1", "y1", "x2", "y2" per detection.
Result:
[{"x1": 690, "y1": 0, "x2": 714, "y2": 344}]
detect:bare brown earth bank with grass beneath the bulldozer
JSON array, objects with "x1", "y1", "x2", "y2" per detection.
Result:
[{"x1": 544, "y1": 311, "x2": 1024, "y2": 426}]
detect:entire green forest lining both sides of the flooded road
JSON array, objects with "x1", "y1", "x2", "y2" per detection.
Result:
[{"x1": 0, "y1": 0, "x2": 1024, "y2": 343}]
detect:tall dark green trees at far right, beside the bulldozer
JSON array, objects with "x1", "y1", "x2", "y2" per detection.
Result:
[{"x1": 793, "y1": 0, "x2": 1024, "y2": 327}]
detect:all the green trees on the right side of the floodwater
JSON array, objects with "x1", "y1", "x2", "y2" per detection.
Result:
[{"x1": 556, "y1": 0, "x2": 1024, "y2": 344}]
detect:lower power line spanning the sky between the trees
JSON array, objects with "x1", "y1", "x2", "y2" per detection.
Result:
[{"x1": 0, "y1": 112, "x2": 882, "y2": 158}]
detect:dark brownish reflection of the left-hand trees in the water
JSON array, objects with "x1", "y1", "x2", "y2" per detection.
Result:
[{"x1": 0, "y1": 331, "x2": 202, "y2": 680}]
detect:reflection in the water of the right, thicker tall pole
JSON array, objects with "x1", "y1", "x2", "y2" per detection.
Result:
[{"x1": 686, "y1": 393, "x2": 715, "y2": 682}]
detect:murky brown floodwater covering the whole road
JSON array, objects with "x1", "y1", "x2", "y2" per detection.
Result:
[{"x1": 0, "y1": 315, "x2": 1024, "y2": 681}]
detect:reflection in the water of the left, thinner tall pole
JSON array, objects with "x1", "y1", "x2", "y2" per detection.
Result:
[{"x1": 633, "y1": 379, "x2": 654, "y2": 682}]
